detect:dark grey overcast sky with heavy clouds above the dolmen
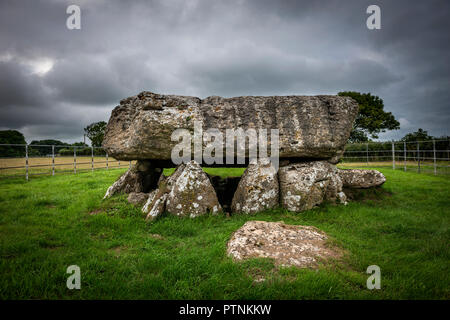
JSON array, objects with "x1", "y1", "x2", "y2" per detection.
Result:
[{"x1": 0, "y1": 0, "x2": 450, "y2": 142}]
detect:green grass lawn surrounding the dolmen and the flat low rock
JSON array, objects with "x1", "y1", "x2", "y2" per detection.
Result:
[{"x1": 0, "y1": 169, "x2": 450, "y2": 299}]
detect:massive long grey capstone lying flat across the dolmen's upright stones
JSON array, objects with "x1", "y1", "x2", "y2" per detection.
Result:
[{"x1": 103, "y1": 91, "x2": 358, "y2": 161}]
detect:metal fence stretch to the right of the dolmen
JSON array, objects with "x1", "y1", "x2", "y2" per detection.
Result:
[{"x1": 342, "y1": 139, "x2": 450, "y2": 174}]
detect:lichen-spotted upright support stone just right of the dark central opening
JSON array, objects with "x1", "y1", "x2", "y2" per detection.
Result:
[{"x1": 231, "y1": 159, "x2": 279, "y2": 214}]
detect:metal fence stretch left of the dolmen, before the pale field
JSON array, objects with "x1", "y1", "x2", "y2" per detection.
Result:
[{"x1": 0, "y1": 144, "x2": 132, "y2": 180}]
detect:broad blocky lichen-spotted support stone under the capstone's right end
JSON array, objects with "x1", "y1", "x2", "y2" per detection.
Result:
[{"x1": 278, "y1": 161, "x2": 346, "y2": 211}]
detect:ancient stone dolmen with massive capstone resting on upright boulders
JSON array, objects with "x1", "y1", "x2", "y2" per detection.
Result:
[{"x1": 103, "y1": 91, "x2": 386, "y2": 220}]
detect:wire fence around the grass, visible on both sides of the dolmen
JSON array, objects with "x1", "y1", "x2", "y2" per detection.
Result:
[{"x1": 0, "y1": 140, "x2": 450, "y2": 180}]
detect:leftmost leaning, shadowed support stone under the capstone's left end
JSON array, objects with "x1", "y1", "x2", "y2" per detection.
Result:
[{"x1": 103, "y1": 161, "x2": 161, "y2": 199}]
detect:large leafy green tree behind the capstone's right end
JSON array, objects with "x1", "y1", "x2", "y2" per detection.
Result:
[{"x1": 338, "y1": 91, "x2": 400, "y2": 142}]
